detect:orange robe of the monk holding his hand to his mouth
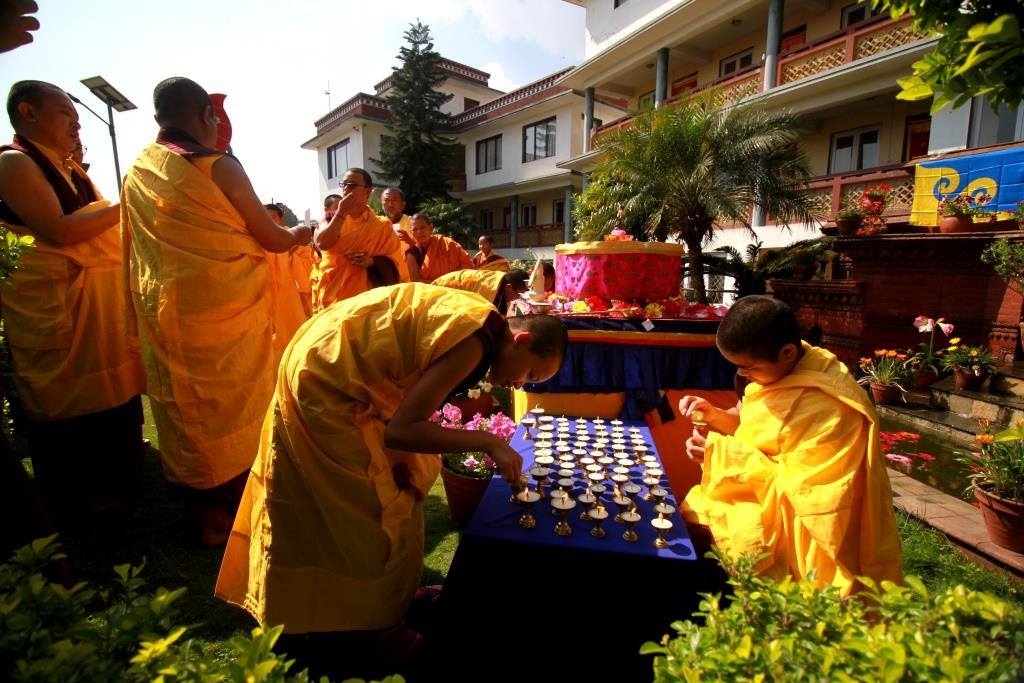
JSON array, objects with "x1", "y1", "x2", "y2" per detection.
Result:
[{"x1": 312, "y1": 209, "x2": 409, "y2": 311}]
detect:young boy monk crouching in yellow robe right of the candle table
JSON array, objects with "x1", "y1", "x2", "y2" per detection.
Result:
[{"x1": 679, "y1": 296, "x2": 902, "y2": 595}]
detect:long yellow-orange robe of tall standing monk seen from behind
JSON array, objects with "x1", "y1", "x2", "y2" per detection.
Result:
[{"x1": 121, "y1": 143, "x2": 273, "y2": 488}]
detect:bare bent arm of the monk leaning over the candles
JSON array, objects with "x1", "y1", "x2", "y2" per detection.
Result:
[{"x1": 384, "y1": 335, "x2": 522, "y2": 481}]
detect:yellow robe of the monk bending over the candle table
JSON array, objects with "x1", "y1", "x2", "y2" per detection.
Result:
[{"x1": 215, "y1": 283, "x2": 496, "y2": 633}]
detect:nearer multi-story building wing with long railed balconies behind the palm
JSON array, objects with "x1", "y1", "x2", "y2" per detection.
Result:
[{"x1": 558, "y1": 0, "x2": 1024, "y2": 255}]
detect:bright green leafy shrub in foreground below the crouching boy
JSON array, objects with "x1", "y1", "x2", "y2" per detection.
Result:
[{"x1": 641, "y1": 557, "x2": 1024, "y2": 683}]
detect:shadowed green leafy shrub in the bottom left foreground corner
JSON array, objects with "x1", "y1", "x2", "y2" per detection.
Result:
[{"x1": 0, "y1": 537, "x2": 401, "y2": 683}]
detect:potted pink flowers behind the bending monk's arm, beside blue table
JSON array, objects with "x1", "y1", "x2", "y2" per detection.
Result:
[{"x1": 433, "y1": 403, "x2": 515, "y2": 526}]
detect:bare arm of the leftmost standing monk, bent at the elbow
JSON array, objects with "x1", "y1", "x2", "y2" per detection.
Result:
[{"x1": 0, "y1": 151, "x2": 120, "y2": 247}]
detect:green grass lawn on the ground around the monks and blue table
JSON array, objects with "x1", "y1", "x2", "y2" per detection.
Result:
[{"x1": 18, "y1": 399, "x2": 1024, "y2": 654}]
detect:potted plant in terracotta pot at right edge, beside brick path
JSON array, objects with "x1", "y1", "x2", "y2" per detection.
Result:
[{"x1": 957, "y1": 421, "x2": 1024, "y2": 553}]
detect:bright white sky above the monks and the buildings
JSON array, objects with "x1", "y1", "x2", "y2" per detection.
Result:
[{"x1": 0, "y1": 0, "x2": 585, "y2": 218}]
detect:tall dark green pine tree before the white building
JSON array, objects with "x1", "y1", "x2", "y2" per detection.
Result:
[{"x1": 373, "y1": 20, "x2": 456, "y2": 212}]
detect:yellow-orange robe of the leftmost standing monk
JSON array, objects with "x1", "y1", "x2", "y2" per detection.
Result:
[{"x1": 0, "y1": 143, "x2": 145, "y2": 421}]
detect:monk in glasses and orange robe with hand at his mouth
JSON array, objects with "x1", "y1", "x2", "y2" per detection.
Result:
[{"x1": 312, "y1": 168, "x2": 409, "y2": 311}]
